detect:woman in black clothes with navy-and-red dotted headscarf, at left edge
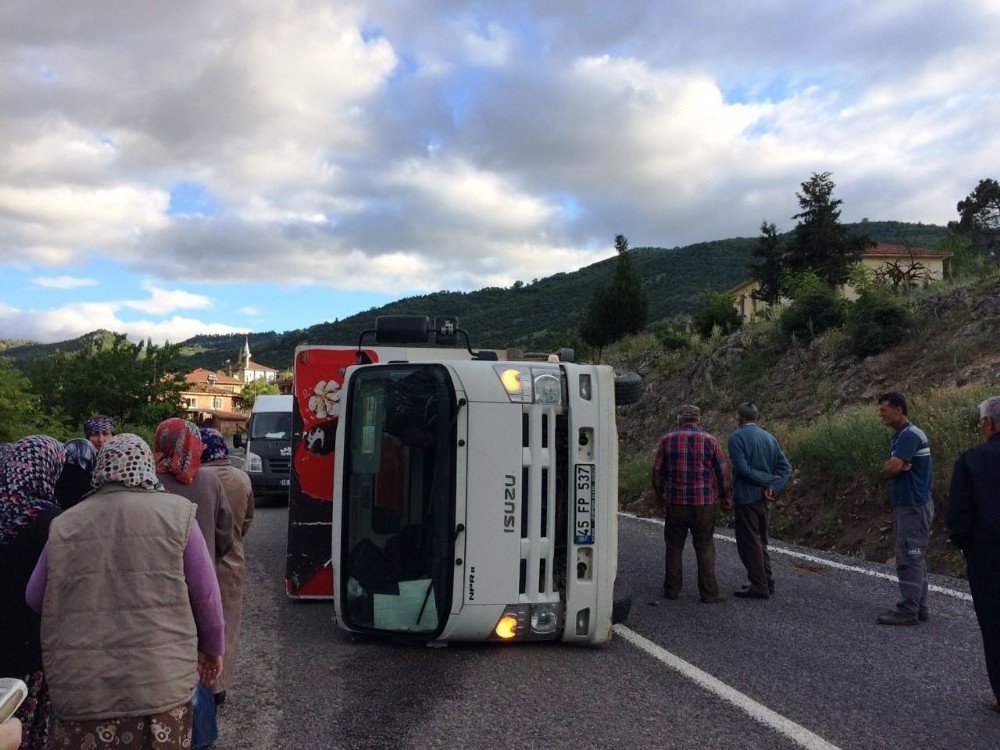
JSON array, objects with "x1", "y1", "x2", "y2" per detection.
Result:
[{"x1": 0, "y1": 435, "x2": 66, "y2": 750}]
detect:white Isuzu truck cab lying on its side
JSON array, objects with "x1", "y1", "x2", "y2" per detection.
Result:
[{"x1": 296, "y1": 316, "x2": 639, "y2": 644}]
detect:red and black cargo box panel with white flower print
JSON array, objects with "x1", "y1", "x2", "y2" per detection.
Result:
[{"x1": 285, "y1": 347, "x2": 378, "y2": 599}]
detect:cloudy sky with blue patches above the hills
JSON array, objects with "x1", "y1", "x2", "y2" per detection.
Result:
[{"x1": 0, "y1": 0, "x2": 1000, "y2": 341}]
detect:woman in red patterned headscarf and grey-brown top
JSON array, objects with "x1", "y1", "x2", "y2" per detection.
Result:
[{"x1": 153, "y1": 417, "x2": 233, "y2": 563}]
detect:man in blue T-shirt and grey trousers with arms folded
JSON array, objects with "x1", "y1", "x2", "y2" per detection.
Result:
[{"x1": 878, "y1": 392, "x2": 934, "y2": 625}]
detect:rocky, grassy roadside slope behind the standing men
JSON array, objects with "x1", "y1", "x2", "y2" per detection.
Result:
[{"x1": 613, "y1": 275, "x2": 1000, "y2": 575}]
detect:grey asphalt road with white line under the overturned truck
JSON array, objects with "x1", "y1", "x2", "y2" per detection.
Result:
[{"x1": 216, "y1": 507, "x2": 1000, "y2": 750}]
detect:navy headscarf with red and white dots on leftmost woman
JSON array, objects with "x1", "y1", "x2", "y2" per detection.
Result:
[{"x1": 0, "y1": 435, "x2": 66, "y2": 546}]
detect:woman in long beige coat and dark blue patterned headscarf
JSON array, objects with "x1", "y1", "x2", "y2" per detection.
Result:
[{"x1": 200, "y1": 427, "x2": 254, "y2": 706}]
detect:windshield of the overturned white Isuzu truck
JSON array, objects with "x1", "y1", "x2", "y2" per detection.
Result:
[{"x1": 340, "y1": 365, "x2": 457, "y2": 635}]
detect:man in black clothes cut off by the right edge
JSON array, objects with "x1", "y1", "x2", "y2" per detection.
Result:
[{"x1": 947, "y1": 396, "x2": 1000, "y2": 712}]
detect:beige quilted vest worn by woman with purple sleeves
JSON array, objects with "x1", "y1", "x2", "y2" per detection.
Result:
[{"x1": 42, "y1": 485, "x2": 198, "y2": 721}]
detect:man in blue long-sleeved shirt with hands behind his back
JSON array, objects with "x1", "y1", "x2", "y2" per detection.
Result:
[{"x1": 729, "y1": 403, "x2": 792, "y2": 599}]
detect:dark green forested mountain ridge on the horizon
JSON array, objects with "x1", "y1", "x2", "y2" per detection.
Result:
[{"x1": 6, "y1": 221, "x2": 945, "y2": 369}]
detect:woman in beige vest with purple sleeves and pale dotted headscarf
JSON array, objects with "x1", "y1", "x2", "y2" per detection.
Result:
[{"x1": 26, "y1": 433, "x2": 225, "y2": 750}]
